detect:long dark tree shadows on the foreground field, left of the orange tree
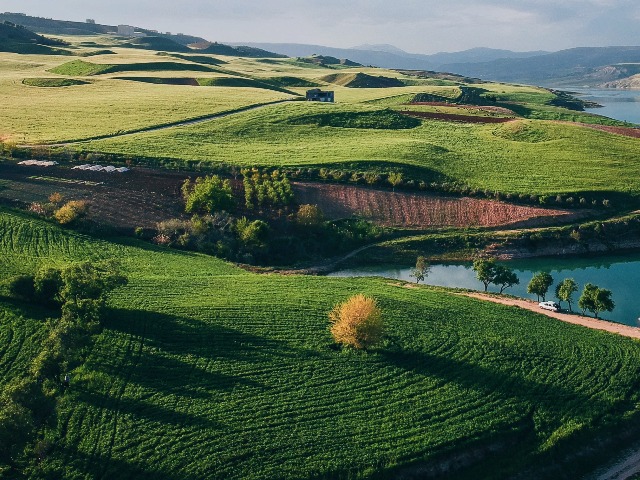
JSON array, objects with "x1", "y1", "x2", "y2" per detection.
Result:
[{"x1": 68, "y1": 310, "x2": 317, "y2": 429}]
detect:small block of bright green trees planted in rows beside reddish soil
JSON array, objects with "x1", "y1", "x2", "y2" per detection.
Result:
[{"x1": 241, "y1": 168, "x2": 293, "y2": 209}]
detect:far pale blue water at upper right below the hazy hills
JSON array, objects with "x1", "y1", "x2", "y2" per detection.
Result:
[{"x1": 566, "y1": 88, "x2": 640, "y2": 124}]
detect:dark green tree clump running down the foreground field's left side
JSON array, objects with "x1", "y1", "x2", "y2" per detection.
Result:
[{"x1": 0, "y1": 261, "x2": 127, "y2": 470}]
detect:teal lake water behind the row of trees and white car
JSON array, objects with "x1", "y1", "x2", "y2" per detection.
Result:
[{"x1": 332, "y1": 254, "x2": 640, "y2": 327}]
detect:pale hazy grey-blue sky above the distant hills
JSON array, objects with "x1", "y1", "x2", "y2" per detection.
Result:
[{"x1": 5, "y1": 0, "x2": 640, "y2": 53}]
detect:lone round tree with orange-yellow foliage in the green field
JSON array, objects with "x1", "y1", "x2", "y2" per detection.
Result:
[{"x1": 329, "y1": 294, "x2": 383, "y2": 349}]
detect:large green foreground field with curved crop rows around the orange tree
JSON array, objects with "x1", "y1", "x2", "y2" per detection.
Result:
[{"x1": 0, "y1": 210, "x2": 640, "y2": 479}]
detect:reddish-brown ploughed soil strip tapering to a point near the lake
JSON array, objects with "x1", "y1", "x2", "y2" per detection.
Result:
[{"x1": 293, "y1": 183, "x2": 591, "y2": 228}]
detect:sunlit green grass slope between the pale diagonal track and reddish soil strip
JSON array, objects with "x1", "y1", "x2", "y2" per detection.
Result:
[{"x1": 84, "y1": 103, "x2": 640, "y2": 194}]
